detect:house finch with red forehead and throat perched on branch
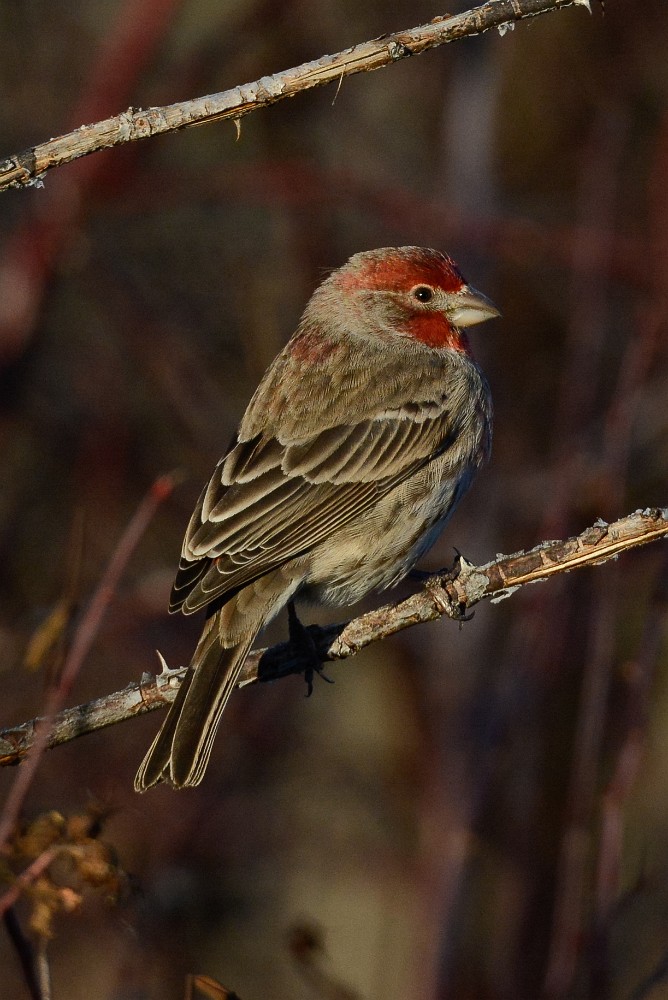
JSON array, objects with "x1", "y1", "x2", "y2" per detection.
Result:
[{"x1": 135, "y1": 247, "x2": 499, "y2": 791}]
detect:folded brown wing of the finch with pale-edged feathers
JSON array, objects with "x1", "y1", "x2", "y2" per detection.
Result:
[{"x1": 170, "y1": 407, "x2": 457, "y2": 613}]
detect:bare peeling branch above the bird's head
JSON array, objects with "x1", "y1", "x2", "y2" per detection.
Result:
[{"x1": 0, "y1": 0, "x2": 589, "y2": 191}]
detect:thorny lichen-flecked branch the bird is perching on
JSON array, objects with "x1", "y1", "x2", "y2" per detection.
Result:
[{"x1": 0, "y1": 508, "x2": 668, "y2": 765}]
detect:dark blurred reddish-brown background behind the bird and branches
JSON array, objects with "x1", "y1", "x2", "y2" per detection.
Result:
[{"x1": 0, "y1": 0, "x2": 668, "y2": 1000}]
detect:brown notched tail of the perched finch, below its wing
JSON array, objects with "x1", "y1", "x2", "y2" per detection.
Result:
[{"x1": 135, "y1": 612, "x2": 256, "y2": 792}]
